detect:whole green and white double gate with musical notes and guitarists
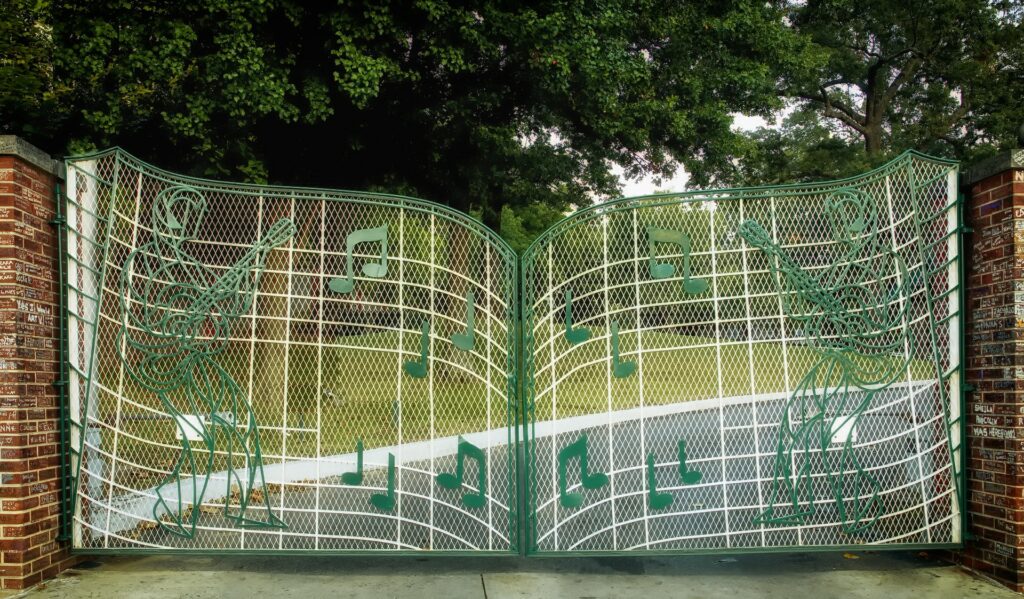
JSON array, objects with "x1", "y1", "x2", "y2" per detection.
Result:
[{"x1": 61, "y1": 149, "x2": 963, "y2": 553}]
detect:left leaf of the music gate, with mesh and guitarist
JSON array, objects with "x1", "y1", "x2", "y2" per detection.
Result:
[{"x1": 67, "y1": 151, "x2": 517, "y2": 552}]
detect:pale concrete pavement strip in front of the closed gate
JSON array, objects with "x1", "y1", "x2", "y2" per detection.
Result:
[{"x1": 0, "y1": 552, "x2": 1020, "y2": 599}]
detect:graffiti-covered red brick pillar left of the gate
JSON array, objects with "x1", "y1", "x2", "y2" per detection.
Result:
[{"x1": 0, "y1": 135, "x2": 72, "y2": 590}]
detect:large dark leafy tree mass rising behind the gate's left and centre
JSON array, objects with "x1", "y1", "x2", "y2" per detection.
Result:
[{"x1": 4, "y1": 0, "x2": 794, "y2": 241}]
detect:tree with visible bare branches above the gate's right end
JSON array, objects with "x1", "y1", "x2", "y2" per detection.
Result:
[{"x1": 695, "y1": 0, "x2": 1024, "y2": 183}]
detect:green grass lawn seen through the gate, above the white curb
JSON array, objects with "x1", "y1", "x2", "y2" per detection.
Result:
[{"x1": 92, "y1": 329, "x2": 933, "y2": 491}]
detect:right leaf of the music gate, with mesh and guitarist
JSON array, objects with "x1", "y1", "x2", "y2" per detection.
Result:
[{"x1": 522, "y1": 154, "x2": 961, "y2": 553}]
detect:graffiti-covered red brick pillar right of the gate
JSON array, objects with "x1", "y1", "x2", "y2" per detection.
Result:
[{"x1": 964, "y1": 149, "x2": 1024, "y2": 592}]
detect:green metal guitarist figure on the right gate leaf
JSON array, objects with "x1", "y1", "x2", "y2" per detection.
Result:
[{"x1": 739, "y1": 189, "x2": 913, "y2": 533}]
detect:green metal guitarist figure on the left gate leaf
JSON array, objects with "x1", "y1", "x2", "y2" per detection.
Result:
[{"x1": 118, "y1": 185, "x2": 295, "y2": 538}]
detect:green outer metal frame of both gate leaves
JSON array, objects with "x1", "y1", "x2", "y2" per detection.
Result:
[{"x1": 52, "y1": 147, "x2": 973, "y2": 557}]
